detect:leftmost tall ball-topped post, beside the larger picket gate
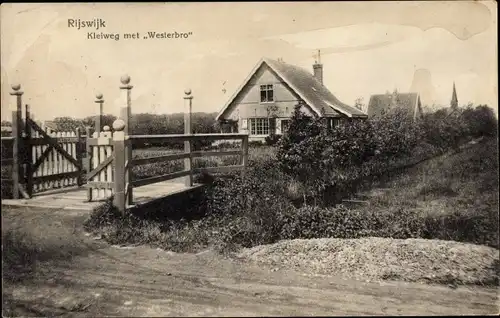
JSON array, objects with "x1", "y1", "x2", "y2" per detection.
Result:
[{"x1": 10, "y1": 84, "x2": 23, "y2": 199}]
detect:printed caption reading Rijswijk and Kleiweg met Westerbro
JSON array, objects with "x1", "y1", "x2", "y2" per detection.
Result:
[{"x1": 68, "y1": 18, "x2": 193, "y2": 41}]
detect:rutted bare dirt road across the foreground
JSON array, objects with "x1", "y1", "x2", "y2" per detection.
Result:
[{"x1": 2, "y1": 207, "x2": 498, "y2": 317}]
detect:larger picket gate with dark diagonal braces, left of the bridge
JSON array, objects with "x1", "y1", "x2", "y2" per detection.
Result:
[{"x1": 23, "y1": 105, "x2": 84, "y2": 197}]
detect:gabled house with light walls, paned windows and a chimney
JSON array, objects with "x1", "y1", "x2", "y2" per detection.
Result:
[{"x1": 216, "y1": 54, "x2": 367, "y2": 141}]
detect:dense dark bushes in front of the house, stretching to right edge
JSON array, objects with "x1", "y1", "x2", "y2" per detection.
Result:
[{"x1": 277, "y1": 100, "x2": 498, "y2": 202}]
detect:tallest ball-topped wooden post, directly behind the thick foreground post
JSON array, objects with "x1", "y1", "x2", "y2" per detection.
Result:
[{"x1": 120, "y1": 75, "x2": 133, "y2": 205}]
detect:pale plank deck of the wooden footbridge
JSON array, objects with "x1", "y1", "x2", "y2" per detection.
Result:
[{"x1": 2, "y1": 180, "x2": 201, "y2": 211}]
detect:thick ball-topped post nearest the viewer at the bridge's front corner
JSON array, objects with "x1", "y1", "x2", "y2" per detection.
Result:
[{"x1": 113, "y1": 119, "x2": 127, "y2": 215}]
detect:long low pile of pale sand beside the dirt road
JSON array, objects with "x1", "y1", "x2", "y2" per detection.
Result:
[{"x1": 238, "y1": 237, "x2": 499, "y2": 285}]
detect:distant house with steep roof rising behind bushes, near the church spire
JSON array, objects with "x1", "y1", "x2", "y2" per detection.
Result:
[{"x1": 367, "y1": 91, "x2": 423, "y2": 120}]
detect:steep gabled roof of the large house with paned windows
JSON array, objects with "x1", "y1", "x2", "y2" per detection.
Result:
[{"x1": 216, "y1": 58, "x2": 367, "y2": 120}]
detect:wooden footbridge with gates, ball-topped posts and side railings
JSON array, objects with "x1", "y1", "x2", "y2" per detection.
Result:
[{"x1": 2, "y1": 76, "x2": 248, "y2": 213}]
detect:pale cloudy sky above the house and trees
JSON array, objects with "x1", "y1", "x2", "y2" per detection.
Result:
[{"x1": 0, "y1": 1, "x2": 498, "y2": 120}]
